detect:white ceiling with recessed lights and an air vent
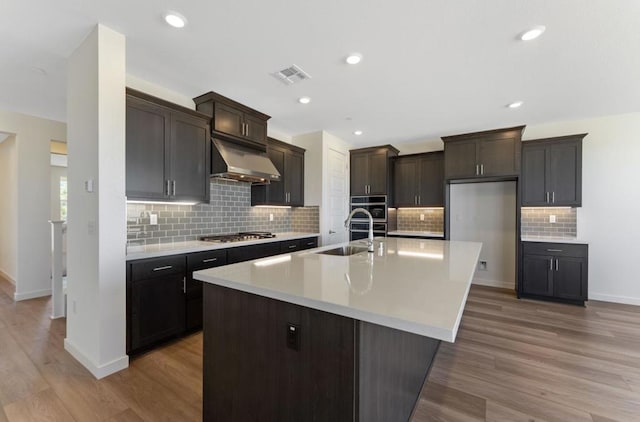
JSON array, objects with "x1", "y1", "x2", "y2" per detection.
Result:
[{"x1": 0, "y1": 0, "x2": 640, "y2": 145}]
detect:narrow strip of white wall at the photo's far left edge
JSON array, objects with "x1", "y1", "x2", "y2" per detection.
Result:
[{"x1": 0, "y1": 135, "x2": 18, "y2": 284}]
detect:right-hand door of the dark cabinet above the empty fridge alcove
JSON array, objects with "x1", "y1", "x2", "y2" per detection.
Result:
[{"x1": 478, "y1": 138, "x2": 520, "y2": 177}]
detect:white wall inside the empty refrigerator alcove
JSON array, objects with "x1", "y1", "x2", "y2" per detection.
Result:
[{"x1": 450, "y1": 182, "x2": 516, "y2": 289}]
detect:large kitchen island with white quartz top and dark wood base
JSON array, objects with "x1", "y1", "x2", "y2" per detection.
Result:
[{"x1": 194, "y1": 238, "x2": 481, "y2": 421}]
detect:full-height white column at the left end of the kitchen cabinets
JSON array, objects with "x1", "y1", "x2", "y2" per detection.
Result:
[{"x1": 65, "y1": 25, "x2": 129, "y2": 378}]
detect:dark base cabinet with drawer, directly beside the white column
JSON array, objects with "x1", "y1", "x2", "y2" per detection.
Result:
[{"x1": 127, "y1": 256, "x2": 185, "y2": 350}]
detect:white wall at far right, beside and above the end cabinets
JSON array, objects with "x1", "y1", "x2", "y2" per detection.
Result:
[{"x1": 524, "y1": 113, "x2": 640, "y2": 305}]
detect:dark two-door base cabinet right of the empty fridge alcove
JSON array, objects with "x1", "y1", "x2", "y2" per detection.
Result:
[{"x1": 518, "y1": 242, "x2": 588, "y2": 305}]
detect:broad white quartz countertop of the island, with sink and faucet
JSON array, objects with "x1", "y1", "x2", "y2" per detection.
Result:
[{"x1": 193, "y1": 237, "x2": 482, "y2": 342}]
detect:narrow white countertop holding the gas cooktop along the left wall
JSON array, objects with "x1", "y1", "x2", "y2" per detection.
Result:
[{"x1": 127, "y1": 232, "x2": 320, "y2": 261}]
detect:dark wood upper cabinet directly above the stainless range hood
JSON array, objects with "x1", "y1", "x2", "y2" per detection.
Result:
[{"x1": 193, "y1": 92, "x2": 270, "y2": 149}]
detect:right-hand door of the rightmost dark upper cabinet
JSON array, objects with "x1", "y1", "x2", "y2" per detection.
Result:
[{"x1": 549, "y1": 141, "x2": 582, "y2": 207}]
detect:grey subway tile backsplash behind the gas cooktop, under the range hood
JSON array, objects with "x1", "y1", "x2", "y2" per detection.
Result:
[{"x1": 127, "y1": 179, "x2": 319, "y2": 244}]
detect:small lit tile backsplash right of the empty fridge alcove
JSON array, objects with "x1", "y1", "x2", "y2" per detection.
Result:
[{"x1": 521, "y1": 208, "x2": 577, "y2": 239}]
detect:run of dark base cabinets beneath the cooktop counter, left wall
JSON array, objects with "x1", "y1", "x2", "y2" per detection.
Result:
[{"x1": 127, "y1": 237, "x2": 318, "y2": 354}]
